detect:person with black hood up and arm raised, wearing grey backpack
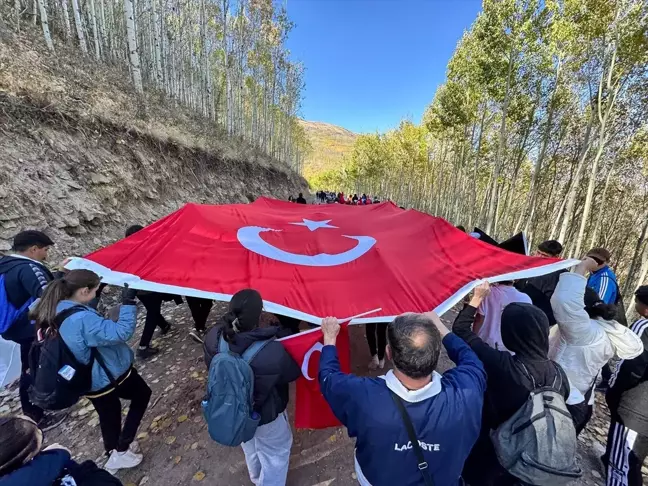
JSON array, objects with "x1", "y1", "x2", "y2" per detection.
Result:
[{"x1": 452, "y1": 282, "x2": 569, "y2": 486}]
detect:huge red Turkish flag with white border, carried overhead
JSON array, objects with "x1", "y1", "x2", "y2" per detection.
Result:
[{"x1": 67, "y1": 198, "x2": 574, "y2": 323}]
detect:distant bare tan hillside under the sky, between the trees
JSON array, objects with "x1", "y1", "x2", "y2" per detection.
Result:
[{"x1": 301, "y1": 120, "x2": 358, "y2": 180}]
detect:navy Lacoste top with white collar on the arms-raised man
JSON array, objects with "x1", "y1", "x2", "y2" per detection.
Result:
[{"x1": 319, "y1": 334, "x2": 486, "y2": 486}]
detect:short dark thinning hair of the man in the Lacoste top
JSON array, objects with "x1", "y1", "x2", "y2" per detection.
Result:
[{"x1": 387, "y1": 314, "x2": 441, "y2": 378}]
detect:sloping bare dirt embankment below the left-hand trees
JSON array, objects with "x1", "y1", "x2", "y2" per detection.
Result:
[{"x1": 0, "y1": 20, "x2": 307, "y2": 257}]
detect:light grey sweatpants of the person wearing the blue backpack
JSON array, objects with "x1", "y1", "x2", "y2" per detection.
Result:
[{"x1": 241, "y1": 412, "x2": 292, "y2": 486}]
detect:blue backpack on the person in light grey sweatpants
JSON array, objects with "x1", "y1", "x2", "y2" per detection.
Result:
[{"x1": 202, "y1": 336, "x2": 271, "y2": 447}]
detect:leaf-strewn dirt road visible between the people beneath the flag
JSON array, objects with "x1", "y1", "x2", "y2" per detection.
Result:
[{"x1": 0, "y1": 304, "x2": 608, "y2": 486}]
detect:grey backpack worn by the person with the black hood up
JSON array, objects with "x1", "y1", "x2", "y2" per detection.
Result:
[{"x1": 491, "y1": 363, "x2": 583, "y2": 486}]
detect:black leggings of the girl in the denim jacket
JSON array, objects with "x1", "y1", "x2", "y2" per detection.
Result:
[{"x1": 90, "y1": 368, "x2": 151, "y2": 452}]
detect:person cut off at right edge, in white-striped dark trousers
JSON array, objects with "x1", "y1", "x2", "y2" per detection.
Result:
[{"x1": 602, "y1": 285, "x2": 648, "y2": 486}]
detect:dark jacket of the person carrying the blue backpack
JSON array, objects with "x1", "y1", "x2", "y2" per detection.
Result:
[{"x1": 203, "y1": 326, "x2": 301, "y2": 425}]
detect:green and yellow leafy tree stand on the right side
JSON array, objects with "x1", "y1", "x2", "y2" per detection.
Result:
[{"x1": 322, "y1": 0, "x2": 648, "y2": 304}]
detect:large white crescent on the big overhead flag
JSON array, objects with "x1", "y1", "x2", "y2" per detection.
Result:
[{"x1": 236, "y1": 226, "x2": 376, "y2": 267}]
